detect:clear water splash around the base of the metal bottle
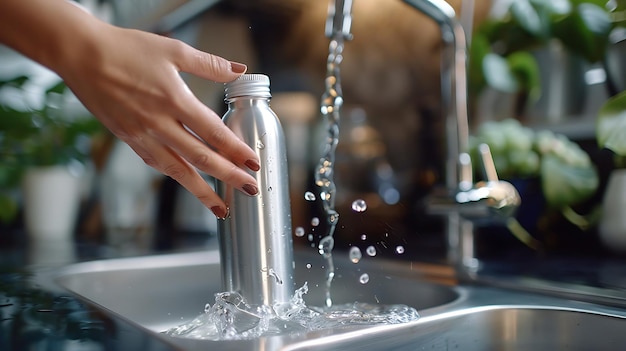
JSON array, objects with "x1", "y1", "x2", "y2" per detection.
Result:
[{"x1": 164, "y1": 284, "x2": 419, "y2": 340}]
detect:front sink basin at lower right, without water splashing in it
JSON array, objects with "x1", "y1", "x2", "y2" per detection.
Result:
[{"x1": 291, "y1": 306, "x2": 626, "y2": 351}]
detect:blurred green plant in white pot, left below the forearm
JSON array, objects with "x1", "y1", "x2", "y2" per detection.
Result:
[{"x1": 0, "y1": 54, "x2": 100, "y2": 237}]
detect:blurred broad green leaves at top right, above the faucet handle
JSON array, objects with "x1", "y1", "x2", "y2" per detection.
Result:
[{"x1": 468, "y1": 0, "x2": 608, "y2": 103}]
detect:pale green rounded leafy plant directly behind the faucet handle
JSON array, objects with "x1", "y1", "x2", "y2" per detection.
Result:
[{"x1": 470, "y1": 119, "x2": 599, "y2": 248}]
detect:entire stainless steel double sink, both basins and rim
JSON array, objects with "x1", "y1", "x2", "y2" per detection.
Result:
[{"x1": 45, "y1": 251, "x2": 626, "y2": 351}]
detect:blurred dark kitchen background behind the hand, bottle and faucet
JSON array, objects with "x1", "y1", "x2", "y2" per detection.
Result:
[{"x1": 0, "y1": 0, "x2": 626, "y2": 270}]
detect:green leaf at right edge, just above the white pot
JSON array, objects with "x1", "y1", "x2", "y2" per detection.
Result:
[{"x1": 596, "y1": 91, "x2": 626, "y2": 156}]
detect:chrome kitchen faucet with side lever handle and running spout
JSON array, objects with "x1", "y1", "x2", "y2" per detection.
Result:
[{"x1": 326, "y1": 0, "x2": 521, "y2": 279}]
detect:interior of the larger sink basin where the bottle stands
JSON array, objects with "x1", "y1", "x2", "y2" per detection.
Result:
[{"x1": 46, "y1": 251, "x2": 460, "y2": 350}]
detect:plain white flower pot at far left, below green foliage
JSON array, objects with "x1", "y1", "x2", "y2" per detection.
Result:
[{"x1": 23, "y1": 166, "x2": 81, "y2": 239}]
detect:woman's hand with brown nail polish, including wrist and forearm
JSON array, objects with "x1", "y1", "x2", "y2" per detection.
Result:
[{"x1": 0, "y1": 0, "x2": 259, "y2": 218}]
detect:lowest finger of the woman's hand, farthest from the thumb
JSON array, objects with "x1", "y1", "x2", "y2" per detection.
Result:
[{"x1": 128, "y1": 138, "x2": 228, "y2": 219}]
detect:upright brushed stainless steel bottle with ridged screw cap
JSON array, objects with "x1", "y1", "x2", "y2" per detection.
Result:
[{"x1": 217, "y1": 74, "x2": 294, "y2": 305}]
